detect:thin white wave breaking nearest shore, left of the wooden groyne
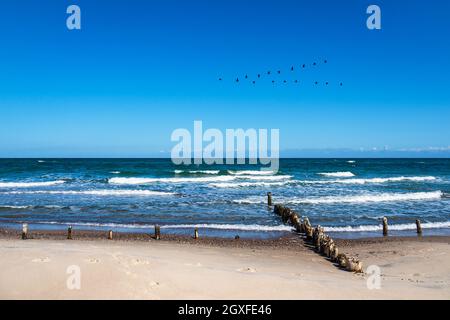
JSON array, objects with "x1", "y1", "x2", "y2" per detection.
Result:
[{"x1": 33, "y1": 221, "x2": 293, "y2": 232}]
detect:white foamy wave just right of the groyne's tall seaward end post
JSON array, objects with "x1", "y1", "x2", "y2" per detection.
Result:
[{"x1": 286, "y1": 191, "x2": 442, "y2": 204}]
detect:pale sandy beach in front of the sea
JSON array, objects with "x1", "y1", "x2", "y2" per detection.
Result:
[{"x1": 0, "y1": 230, "x2": 450, "y2": 299}]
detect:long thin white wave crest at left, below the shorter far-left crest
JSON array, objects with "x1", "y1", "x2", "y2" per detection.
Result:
[{"x1": 5, "y1": 189, "x2": 175, "y2": 196}]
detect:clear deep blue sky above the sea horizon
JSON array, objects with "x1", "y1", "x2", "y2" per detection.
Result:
[{"x1": 0, "y1": 0, "x2": 450, "y2": 157}]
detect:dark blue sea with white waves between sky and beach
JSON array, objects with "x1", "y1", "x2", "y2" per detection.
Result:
[{"x1": 0, "y1": 159, "x2": 450, "y2": 238}]
